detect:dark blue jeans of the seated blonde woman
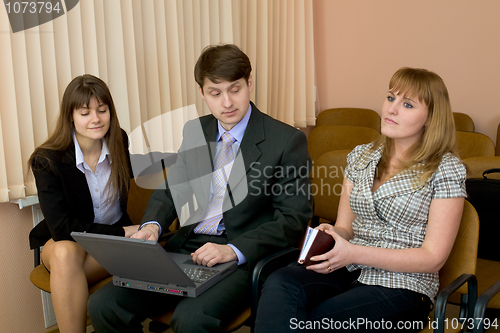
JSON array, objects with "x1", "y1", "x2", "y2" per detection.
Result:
[{"x1": 255, "y1": 267, "x2": 432, "y2": 333}]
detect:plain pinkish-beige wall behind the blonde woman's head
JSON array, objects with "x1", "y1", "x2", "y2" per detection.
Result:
[{"x1": 314, "y1": 0, "x2": 500, "y2": 141}]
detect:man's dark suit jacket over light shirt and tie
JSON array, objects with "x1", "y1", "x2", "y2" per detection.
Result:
[{"x1": 142, "y1": 103, "x2": 313, "y2": 269}]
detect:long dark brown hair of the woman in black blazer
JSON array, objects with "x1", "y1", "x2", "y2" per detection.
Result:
[{"x1": 28, "y1": 74, "x2": 130, "y2": 200}]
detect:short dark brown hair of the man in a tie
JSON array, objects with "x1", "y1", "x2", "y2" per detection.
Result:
[{"x1": 194, "y1": 44, "x2": 252, "y2": 91}]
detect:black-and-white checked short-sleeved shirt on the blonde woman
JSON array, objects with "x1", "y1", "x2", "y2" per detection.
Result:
[{"x1": 345, "y1": 144, "x2": 466, "y2": 300}]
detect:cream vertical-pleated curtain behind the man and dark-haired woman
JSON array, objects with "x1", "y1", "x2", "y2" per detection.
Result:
[{"x1": 0, "y1": 0, "x2": 316, "y2": 202}]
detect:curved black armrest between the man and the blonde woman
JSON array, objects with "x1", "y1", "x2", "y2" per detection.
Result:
[{"x1": 252, "y1": 248, "x2": 300, "y2": 322}]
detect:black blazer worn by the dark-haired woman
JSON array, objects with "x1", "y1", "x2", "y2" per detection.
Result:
[{"x1": 29, "y1": 130, "x2": 132, "y2": 249}]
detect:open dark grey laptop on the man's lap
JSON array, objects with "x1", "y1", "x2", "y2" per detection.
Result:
[{"x1": 71, "y1": 232, "x2": 238, "y2": 297}]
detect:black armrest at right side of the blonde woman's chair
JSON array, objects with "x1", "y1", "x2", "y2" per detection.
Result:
[{"x1": 434, "y1": 274, "x2": 477, "y2": 333}]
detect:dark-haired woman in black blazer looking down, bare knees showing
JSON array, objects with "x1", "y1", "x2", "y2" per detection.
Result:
[{"x1": 28, "y1": 74, "x2": 137, "y2": 332}]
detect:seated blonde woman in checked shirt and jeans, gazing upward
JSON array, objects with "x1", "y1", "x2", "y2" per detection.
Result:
[{"x1": 255, "y1": 68, "x2": 466, "y2": 333}]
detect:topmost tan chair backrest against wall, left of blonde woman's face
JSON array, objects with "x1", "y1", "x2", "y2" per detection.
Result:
[{"x1": 316, "y1": 108, "x2": 380, "y2": 133}]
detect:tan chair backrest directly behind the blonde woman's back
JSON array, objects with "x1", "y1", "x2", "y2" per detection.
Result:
[{"x1": 439, "y1": 200, "x2": 479, "y2": 294}]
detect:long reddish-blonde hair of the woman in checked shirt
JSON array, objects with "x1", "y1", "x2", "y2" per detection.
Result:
[{"x1": 372, "y1": 67, "x2": 457, "y2": 185}]
